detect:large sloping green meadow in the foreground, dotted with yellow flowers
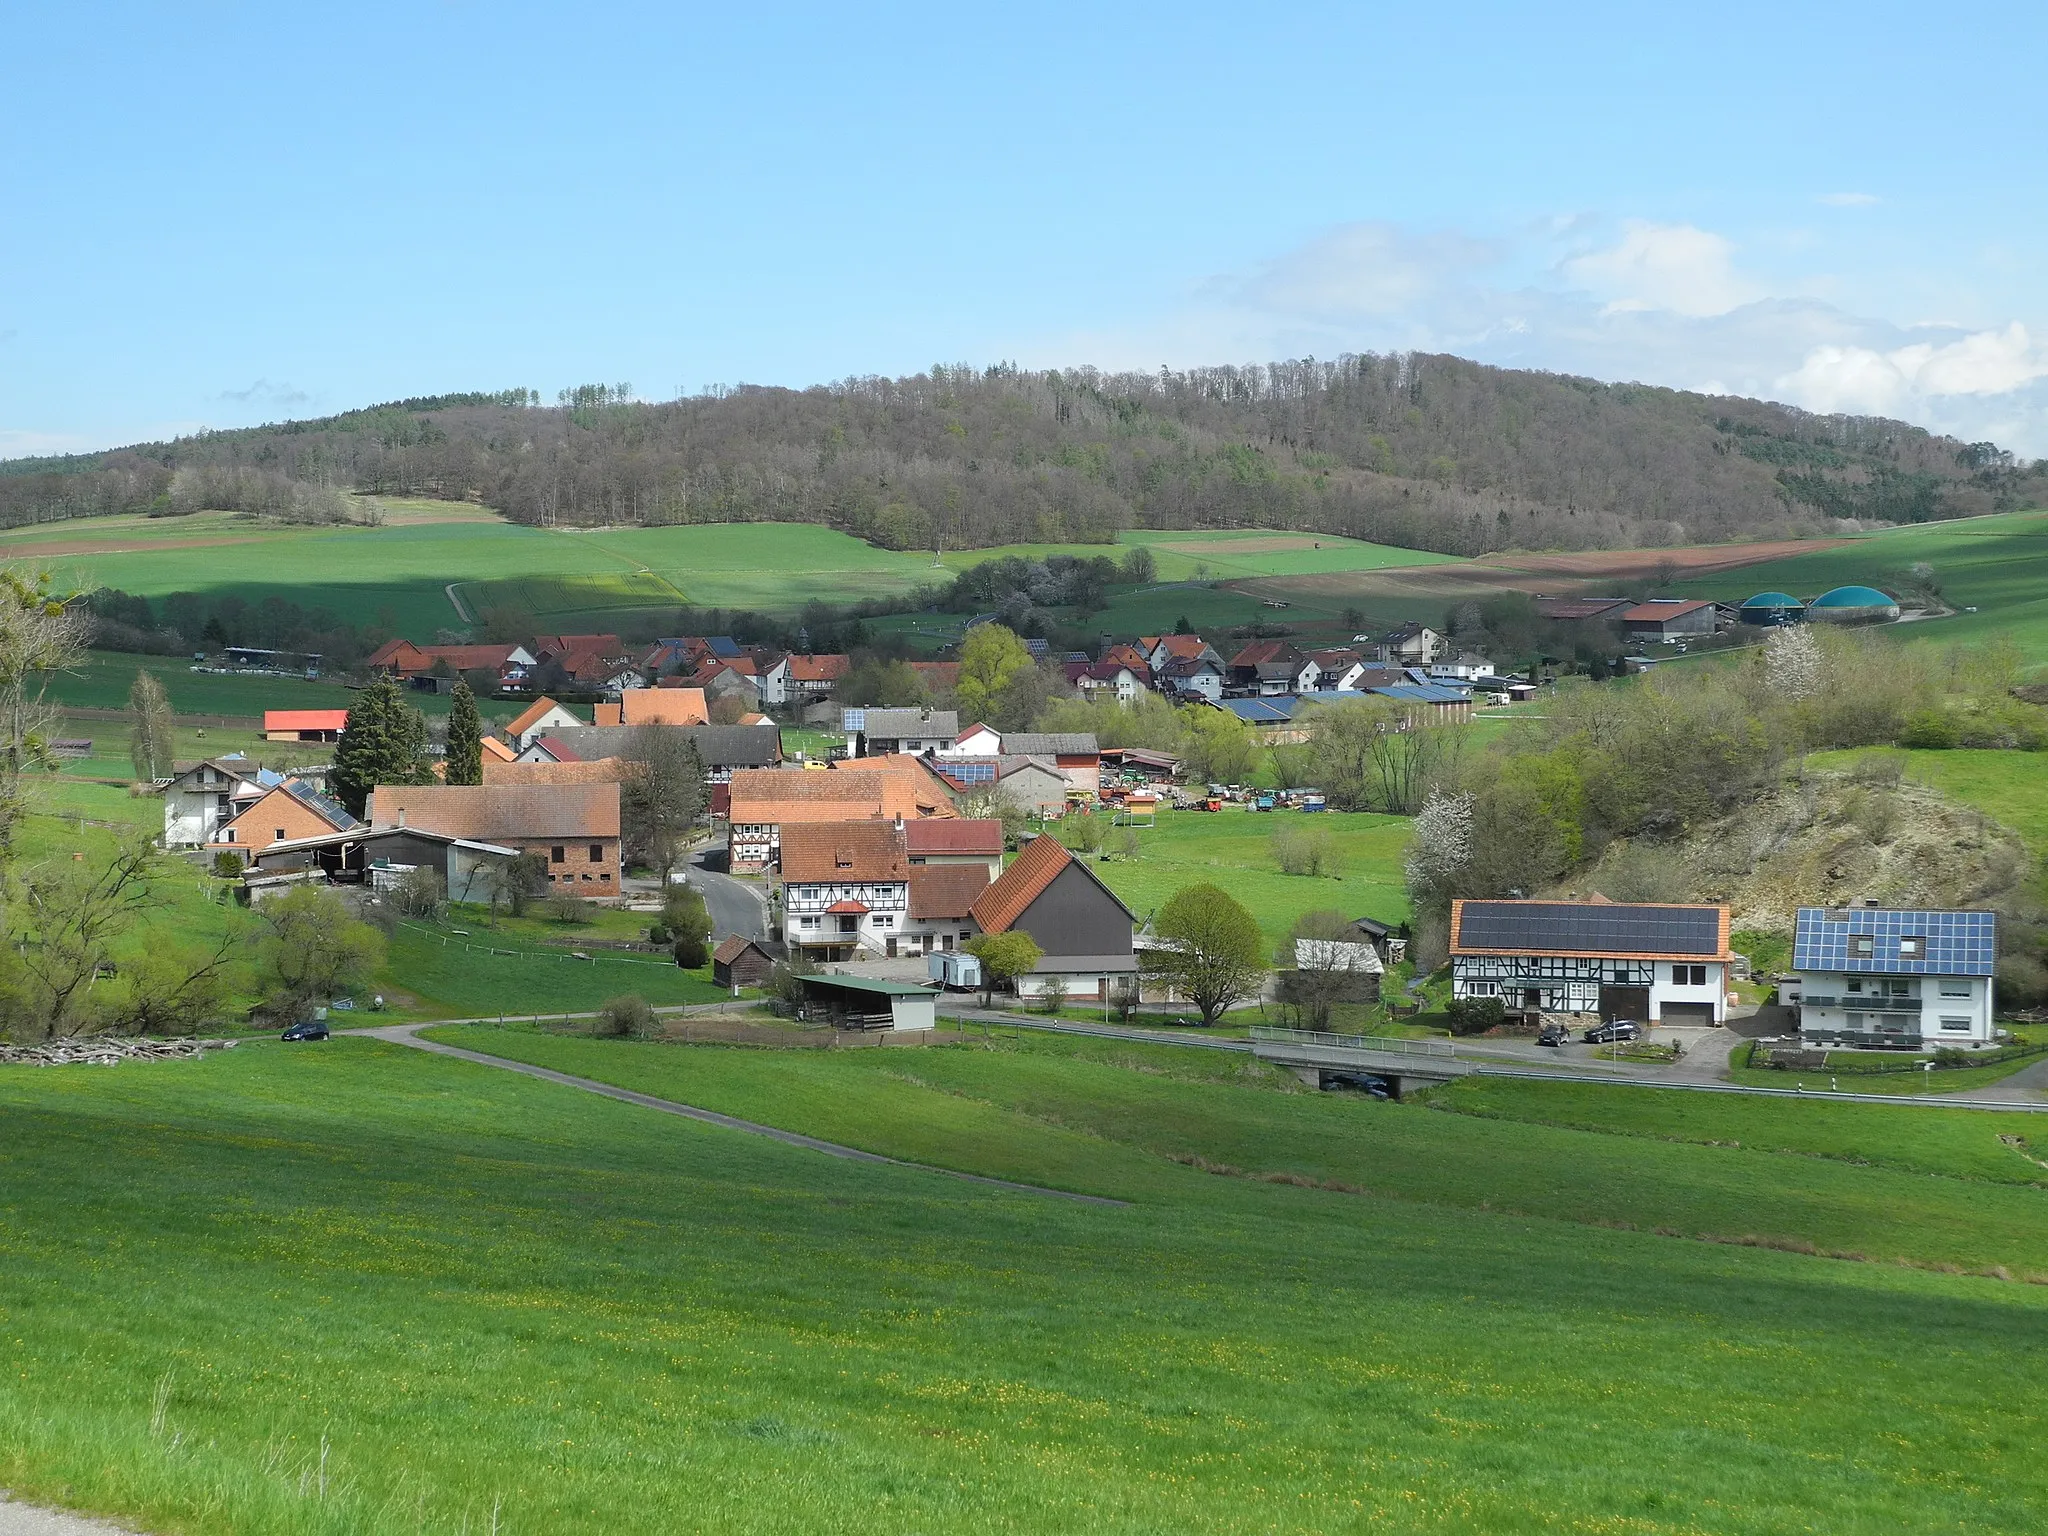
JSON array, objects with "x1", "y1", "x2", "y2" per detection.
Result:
[{"x1": 0, "y1": 1030, "x2": 2048, "y2": 1536}]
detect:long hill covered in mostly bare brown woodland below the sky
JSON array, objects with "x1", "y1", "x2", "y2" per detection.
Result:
[{"x1": 0, "y1": 354, "x2": 2048, "y2": 555}]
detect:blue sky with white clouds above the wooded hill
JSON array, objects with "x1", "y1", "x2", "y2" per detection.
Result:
[{"x1": 0, "y1": 0, "x2": 2048, "y2": 457}]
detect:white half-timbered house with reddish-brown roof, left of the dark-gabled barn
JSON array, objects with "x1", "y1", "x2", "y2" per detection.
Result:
[{"x1": 782, "y1": 821, "x2": 909, "y2": 961}]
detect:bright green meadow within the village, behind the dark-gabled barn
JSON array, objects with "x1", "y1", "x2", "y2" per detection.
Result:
[{"x1": 1092, "y1": 805, "x2": 1409, "y2": 944}]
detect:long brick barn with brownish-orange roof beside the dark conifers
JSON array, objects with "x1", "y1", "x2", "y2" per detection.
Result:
[{"x1": 369, "y1": 782, "x2": 621, "y2": 897}]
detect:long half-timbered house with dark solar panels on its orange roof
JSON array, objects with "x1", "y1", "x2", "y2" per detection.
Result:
[{"x1": 1450, "y1": 899, "x2": 1735, "y2": 1024}]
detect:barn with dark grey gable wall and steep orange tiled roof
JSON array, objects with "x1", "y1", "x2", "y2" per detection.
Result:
[{"x1": 971, "y1": 838, "x2": 1139, "y2": 1001}]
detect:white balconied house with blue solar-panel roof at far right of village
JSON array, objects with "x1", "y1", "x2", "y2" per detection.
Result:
[{"x1": 1780, "y1": 905, "x2": 1999, "y2": 1051}]
